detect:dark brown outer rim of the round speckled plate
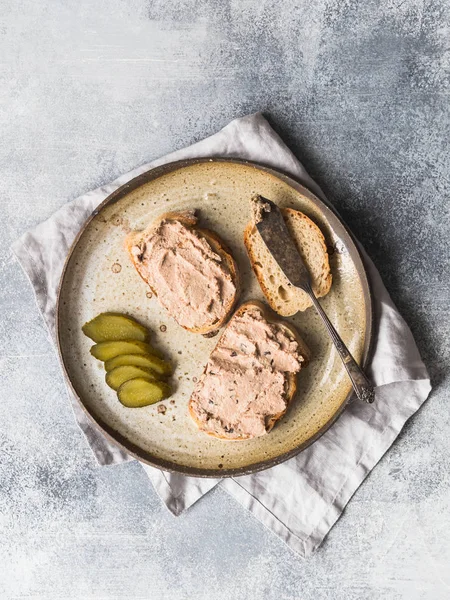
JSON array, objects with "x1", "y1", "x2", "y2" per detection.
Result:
[{"x1": 55, "y1": 157, "x2": 375, "y2": 478}]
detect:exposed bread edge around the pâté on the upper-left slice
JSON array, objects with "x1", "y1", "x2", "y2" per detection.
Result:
[{"x1": 125, "y1": 211, "x2": 240, "y2": 335}]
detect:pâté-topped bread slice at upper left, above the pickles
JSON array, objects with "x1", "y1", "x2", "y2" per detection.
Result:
[{"x1": 126, "y1": 211, "x2": 239, "y2": 334}]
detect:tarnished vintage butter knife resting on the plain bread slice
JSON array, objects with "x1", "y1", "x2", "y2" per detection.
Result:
[{"x1": 253, "y1": 196, "x2": 375, "y2": 404}]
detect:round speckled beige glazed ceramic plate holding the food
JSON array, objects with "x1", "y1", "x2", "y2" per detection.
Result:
[{"x1": 57, "y1": 159, "x2": 372, "y2": 477}]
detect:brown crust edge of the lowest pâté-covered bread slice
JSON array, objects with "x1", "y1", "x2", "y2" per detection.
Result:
[{"x1": 188, "y1": 300, "x2": 310, "y2": 441}]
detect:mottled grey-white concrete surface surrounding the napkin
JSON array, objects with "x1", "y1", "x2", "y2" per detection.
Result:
[{"x1": 0, "y1": 0, "x2": 450, "y2": 600}]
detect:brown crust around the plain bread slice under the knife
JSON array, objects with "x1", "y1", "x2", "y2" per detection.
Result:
[{"x1": 244, "y1": 208, "x2": 332, "y2": 317}]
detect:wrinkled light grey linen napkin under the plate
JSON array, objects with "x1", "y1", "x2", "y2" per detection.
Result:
[{"x1": 12, "y1": 114, "x2": 431, "y2": 557}]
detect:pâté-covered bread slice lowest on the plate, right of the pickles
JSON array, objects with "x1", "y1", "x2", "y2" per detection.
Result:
[{"x1": 189, "y1": 301, "x2": 309, "y2": 441}]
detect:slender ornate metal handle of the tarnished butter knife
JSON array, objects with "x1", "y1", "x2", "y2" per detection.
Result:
[{"x1": 304, "y1": 286, "x2": 375, "y2": 404}]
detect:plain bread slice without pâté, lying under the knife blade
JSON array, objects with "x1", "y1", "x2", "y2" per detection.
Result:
[{"x1": 244, "y1": 208, "x2": 332, "y2": 317}]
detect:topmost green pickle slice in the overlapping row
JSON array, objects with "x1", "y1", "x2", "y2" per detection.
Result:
[{"x1": 82, "y1": 313, "x2": 149, "y2": 343}]
